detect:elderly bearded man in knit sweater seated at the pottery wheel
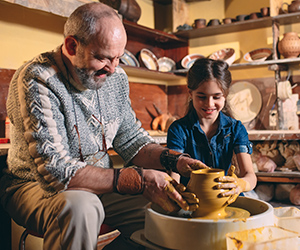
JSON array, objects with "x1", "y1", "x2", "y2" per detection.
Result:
[{"x1": 1, "y1": 2, "x2": 205, "y2": 250}]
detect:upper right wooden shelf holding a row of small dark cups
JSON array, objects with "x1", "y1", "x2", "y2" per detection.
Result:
[{"x1": 174, "y1": 12, "x2": 300, "y2": 39}]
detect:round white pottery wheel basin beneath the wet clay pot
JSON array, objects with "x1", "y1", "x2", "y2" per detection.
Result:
[{"x1": 144, "y1": 197, "x2": 274, "y2": 250}]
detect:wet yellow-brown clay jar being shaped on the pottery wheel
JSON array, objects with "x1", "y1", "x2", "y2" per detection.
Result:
[{"x1": 187, "y1": 168, "x2": 229, "y2": 219}]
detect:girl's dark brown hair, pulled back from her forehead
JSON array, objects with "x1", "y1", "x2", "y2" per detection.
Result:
[{"x1": 187, "y1": 58, "x2": 231, "y2": 115}]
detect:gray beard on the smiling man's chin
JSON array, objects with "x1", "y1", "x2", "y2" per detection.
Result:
[{"x1": 75, "y1": 67, "x2": 110, "y2": 90}]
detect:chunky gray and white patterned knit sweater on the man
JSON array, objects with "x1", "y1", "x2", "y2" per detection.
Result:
[{"x1": 2, "y1": 47, "x2": 153, "y2": 196}]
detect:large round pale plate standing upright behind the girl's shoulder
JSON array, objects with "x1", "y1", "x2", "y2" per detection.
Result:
[{"x1": 227, "y1": 81, "x2": 262, "y2": 123}]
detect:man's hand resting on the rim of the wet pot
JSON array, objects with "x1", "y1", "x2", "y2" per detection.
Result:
[{"x1": 176, "y1": 156, "x2": 209, "y2": 177}]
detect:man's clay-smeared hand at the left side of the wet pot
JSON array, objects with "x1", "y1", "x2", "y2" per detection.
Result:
[{"x1": 143, "y1": 169, "x2": 199, "y2": 212}]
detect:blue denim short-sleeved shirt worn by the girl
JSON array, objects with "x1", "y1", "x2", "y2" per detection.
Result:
[{"x1": 167, "y1": 109, "x2": 252, "y2": 185}]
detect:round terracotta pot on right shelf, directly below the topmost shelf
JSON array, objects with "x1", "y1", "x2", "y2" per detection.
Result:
[{"x1": 278, "y1": 32, "x2": 300, "y2": 58}]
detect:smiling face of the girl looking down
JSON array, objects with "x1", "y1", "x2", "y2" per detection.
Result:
[{"x1": 190, "y1": 80, "x2": 225, "y2": 121}]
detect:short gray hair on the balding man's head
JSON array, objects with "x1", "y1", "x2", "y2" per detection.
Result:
[{"x1": 64, "y1": 2, "x2": 119, "y2": 45}]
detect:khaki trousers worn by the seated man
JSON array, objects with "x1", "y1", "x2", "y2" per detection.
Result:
[{"x1": 2, "y1": 182, "x2": 149, "y2": 250}]
